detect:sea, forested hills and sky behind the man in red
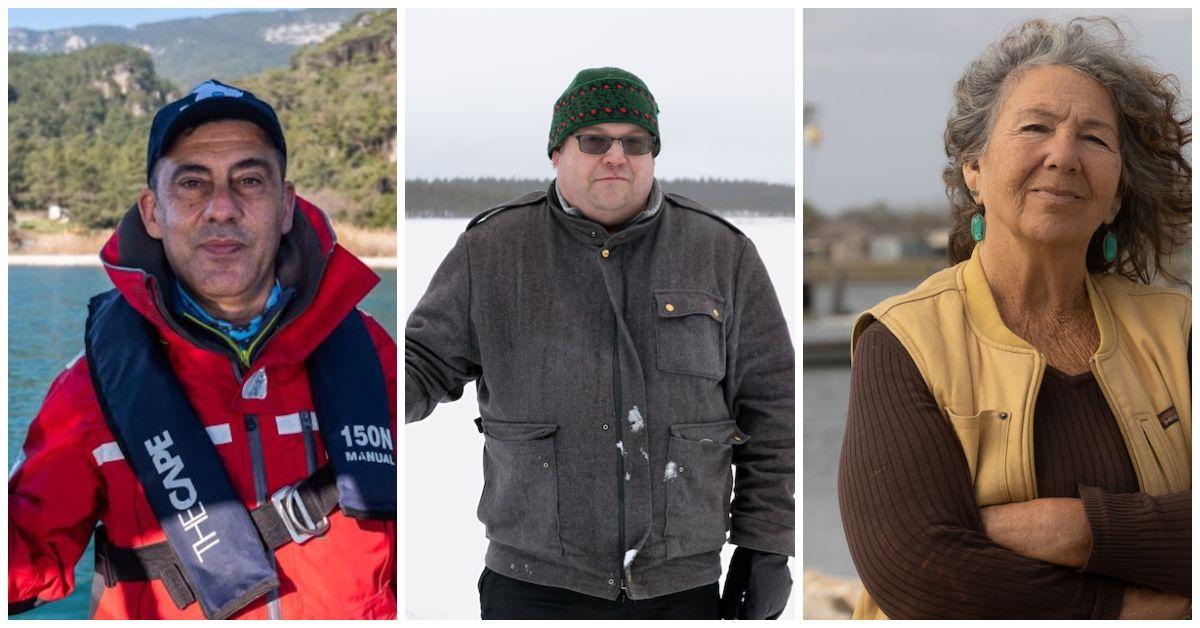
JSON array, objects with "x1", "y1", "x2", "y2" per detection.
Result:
[{"x1": 7, "y1": 8, "x2": 396, "y2": 618}]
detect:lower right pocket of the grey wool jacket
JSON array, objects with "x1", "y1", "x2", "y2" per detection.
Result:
[{"x1": 662, "y1": 420, "x2": 750, "y2": 560}]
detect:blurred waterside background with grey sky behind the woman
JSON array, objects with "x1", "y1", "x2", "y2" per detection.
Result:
[{"x1": 803, "y1": 8, "x2": 1192, "y2": 618}]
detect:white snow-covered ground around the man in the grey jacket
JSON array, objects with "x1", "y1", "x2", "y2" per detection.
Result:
[{"x1": 400, "y1": 217, "x2": 800, "y2": 620}]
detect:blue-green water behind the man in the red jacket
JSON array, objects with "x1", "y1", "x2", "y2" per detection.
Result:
[{"x1": 8, "y1": 267, "x2": 396, "y2": 620}]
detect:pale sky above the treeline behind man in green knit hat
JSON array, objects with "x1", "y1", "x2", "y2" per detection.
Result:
[{"x1": 404, "y1": 10, "x2": 798, "y2": 184}]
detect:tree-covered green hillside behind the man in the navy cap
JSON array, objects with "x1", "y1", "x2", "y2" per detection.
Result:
[{"x1": 8, "y1": 11, "x2": 396, "y2": 228}]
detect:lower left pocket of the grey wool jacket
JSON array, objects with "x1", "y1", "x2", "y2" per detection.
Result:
[{"x1": 475, "y1": 421, "x2": 563, "y2": 556}]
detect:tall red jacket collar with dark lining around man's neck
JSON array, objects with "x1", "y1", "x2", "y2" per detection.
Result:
[{"x1": 100, "y1": 196, "x2": 379, "y2": 367}]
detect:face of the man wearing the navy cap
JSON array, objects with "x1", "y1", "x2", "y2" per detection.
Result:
[{"x1": 138, "y1": 120, "x2": 295, "y2": 318}]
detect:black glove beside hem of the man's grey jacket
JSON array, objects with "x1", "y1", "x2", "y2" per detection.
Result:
[{"x1": 721, "y1": 548, "x2": 792, "y2": 620}]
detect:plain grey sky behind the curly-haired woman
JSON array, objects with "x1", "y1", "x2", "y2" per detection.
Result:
[{"x1": 803, "y1": 8, "x2": 1192, "y2": 211}]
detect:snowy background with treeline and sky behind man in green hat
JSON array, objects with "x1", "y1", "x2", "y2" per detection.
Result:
[{"x1": 402, "y1": 8, "x2": 799, "y2": 618}]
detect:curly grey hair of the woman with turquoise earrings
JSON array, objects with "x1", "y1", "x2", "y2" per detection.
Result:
[{"x1": 942, "y1": 17, "x2": 1192, "y2": 283}]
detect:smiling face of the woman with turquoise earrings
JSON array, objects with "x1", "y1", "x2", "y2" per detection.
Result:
[{"x1": 962, "y1": 66, "x2": 1121, "y2": 251}]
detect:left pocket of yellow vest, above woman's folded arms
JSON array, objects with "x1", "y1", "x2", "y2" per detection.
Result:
[{"x1": 944, "y1": 408, "x2": 1012, "y2": 508}]
